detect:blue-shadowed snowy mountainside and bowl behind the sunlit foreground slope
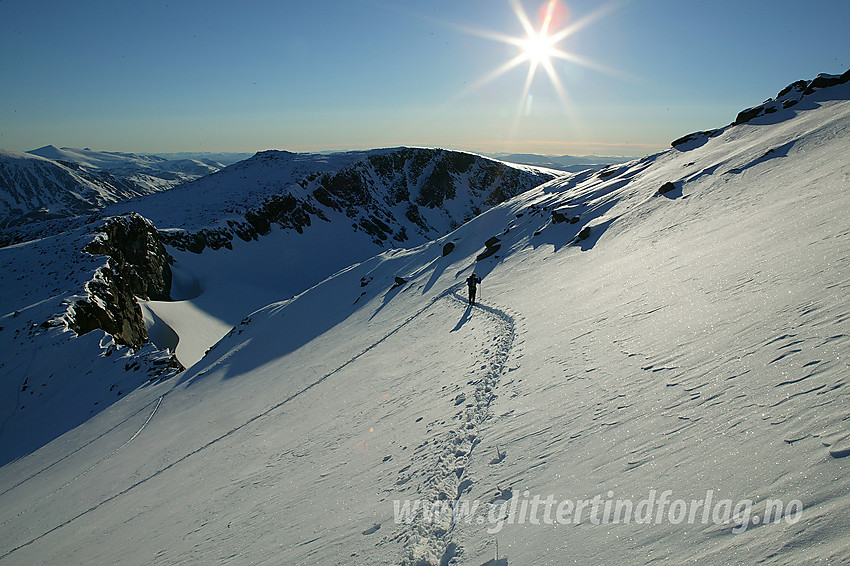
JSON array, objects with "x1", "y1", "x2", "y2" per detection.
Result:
[{"x1": 0, "y1": 149, "x2": 555, "y2": 459}]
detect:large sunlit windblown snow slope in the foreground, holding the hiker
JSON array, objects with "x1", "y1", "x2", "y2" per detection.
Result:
[{"x1": 0, "y1": 84, "x2": 850, "y2": 565}]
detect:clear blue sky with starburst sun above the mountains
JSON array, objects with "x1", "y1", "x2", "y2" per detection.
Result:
[{"x1": 0, "y1": 0, "x2": 850, "y2": 156}]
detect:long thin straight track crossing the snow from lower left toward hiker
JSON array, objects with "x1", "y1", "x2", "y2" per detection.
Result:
[{"x1": 0, "y1": 288, "x2": 452, "y2": 560}]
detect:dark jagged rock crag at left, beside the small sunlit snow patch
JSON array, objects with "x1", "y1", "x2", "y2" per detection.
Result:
[{"x1": 66, "y1": 214, "x2": 174, "y2": 350}]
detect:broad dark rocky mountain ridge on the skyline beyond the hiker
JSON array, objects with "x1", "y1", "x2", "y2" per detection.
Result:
[{"x1": 107, "y1": 148, "x2": 562, "y2": 251}]
